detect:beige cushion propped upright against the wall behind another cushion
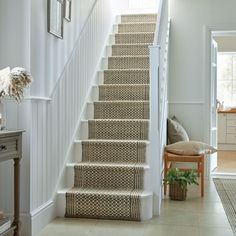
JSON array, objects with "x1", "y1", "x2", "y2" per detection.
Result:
[{"x1": 167, "y1": 117, "x2": 189, "y2": 144}]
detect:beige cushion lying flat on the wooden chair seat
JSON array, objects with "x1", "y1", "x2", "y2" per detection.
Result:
[{"x1": 165, "y1": 141, "x2": 217, "y2": 156}]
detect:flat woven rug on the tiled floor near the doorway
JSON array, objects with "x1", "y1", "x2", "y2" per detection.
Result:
[{"x1": 213, "y1": 179, "x2": 236, "y2": 235}]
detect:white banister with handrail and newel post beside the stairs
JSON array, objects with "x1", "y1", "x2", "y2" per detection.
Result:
[{"x1": 149, "y1": 0, "x2": 170, "y2": 214}]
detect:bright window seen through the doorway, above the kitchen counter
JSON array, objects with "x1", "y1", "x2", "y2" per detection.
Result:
[{"x1": 217, "y1": 52, "x2": 236, "y2": 107}]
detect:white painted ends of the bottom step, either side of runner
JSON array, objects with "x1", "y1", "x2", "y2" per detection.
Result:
[{"x1": 56, "y1": 188, "x2": 153, "y2": 221}]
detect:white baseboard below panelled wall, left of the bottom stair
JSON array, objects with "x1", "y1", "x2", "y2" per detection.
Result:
[{"x1": 30, "y1": 200, "x2": 56, "y2": 236}]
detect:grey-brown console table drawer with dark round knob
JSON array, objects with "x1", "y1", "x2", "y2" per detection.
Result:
[{"x1": 0, "y1": 137, "x2": 18, "y2": 158}]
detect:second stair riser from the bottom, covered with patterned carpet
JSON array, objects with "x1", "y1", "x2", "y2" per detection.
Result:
[{"x1": 72, "y1": 166, "x2": 150, "y2": 191}]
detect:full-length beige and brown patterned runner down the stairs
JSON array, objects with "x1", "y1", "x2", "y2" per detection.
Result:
[{"x1": 65, "y1": 14, "x2": 157, "y2": 221}]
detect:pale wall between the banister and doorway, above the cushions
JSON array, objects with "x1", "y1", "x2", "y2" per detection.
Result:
[{"x1": 168, "y1": 0, "x2": 236, "y2": 142}]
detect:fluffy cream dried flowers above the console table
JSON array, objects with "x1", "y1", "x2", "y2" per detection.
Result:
[{"x1": 0, "y1": 67, "x2": 33, "y2": 102}]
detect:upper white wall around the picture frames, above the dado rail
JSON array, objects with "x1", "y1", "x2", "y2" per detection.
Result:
[{"x1": 0, "y1": 0, "x2": 95, "y2": 97}]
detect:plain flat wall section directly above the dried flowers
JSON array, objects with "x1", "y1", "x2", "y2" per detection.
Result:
[{"x1": 0, "y1": 0, "x2": 30, "y2": 69}]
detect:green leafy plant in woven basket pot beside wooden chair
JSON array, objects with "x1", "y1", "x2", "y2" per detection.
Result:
[{"x1": 164, "y1": 168, "x2": 198, "y2": 201}]
